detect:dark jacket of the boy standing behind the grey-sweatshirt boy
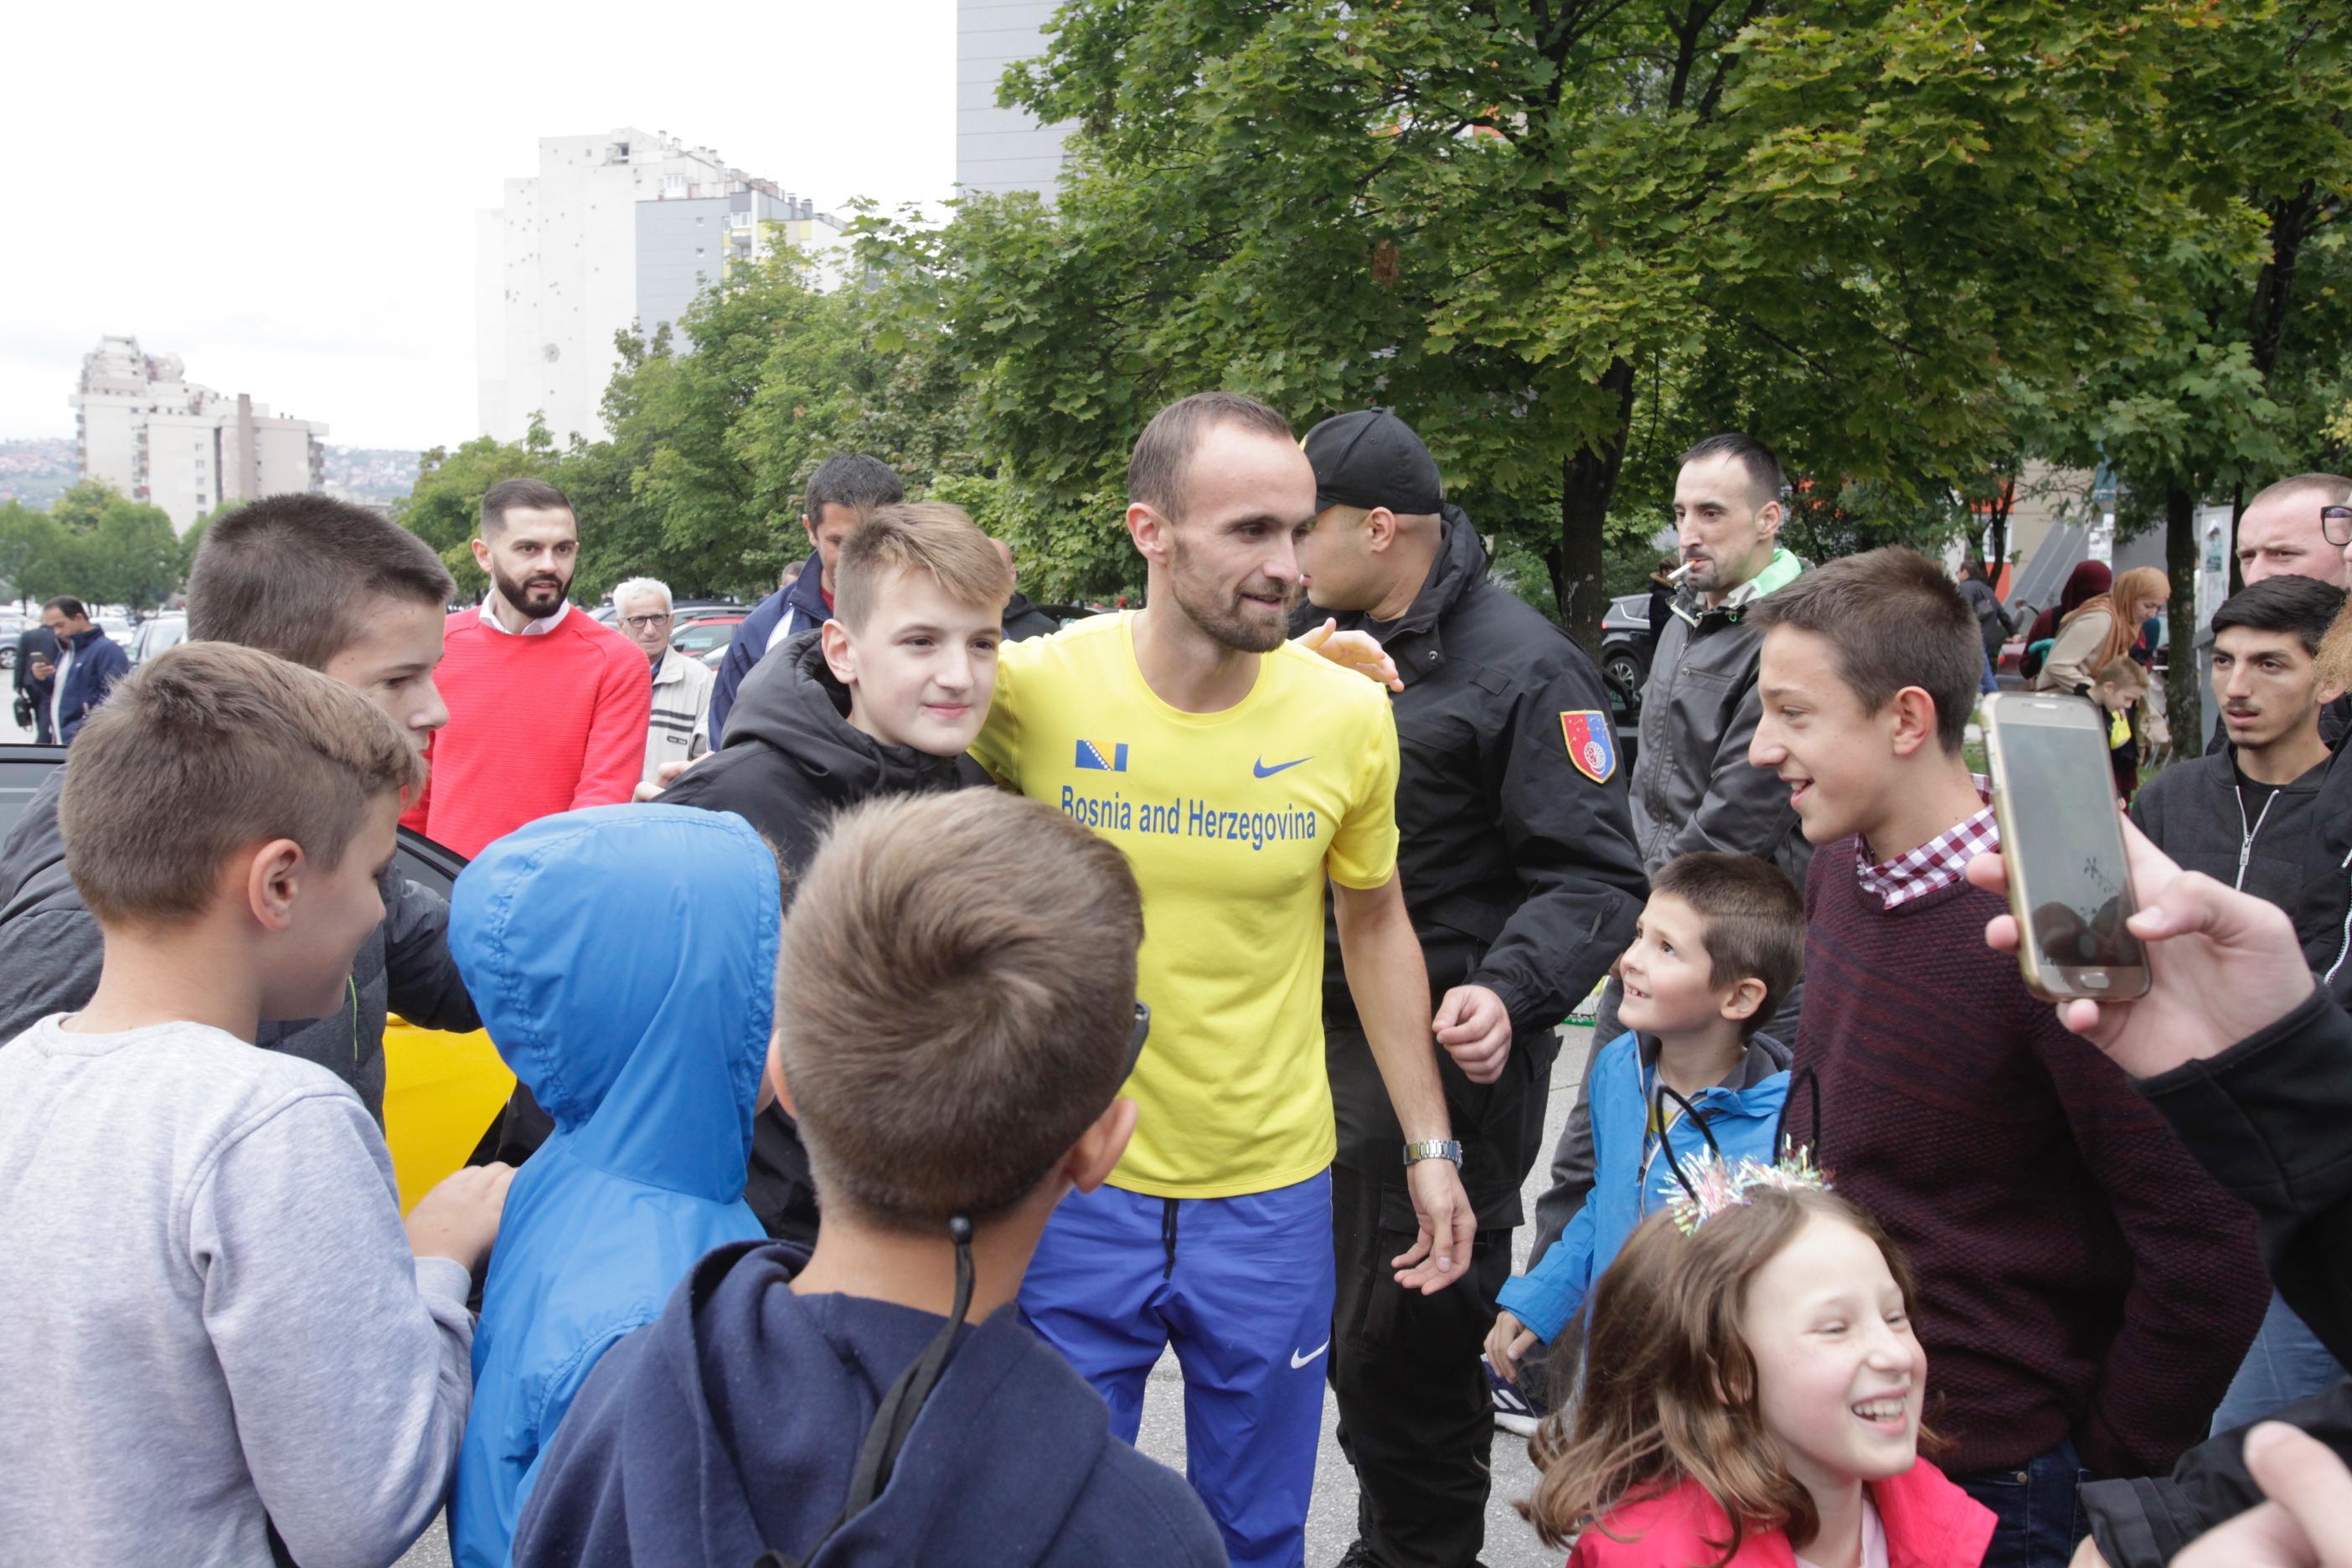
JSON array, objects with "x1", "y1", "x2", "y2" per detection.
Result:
[{"x1": 0, "y1": 764, "x2": 482, "y2": 1124}]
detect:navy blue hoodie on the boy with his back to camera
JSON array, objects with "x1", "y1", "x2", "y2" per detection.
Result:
[{"x1": 515, "y1": 1241, "x2": 1225, "y2": 1568}]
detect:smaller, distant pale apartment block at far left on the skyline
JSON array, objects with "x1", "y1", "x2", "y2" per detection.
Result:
[{"x1": 66, "y1": 338, "x2": 327, "y2": 534}]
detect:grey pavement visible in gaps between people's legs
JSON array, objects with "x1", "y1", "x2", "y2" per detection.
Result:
[{"x1": 400, "y1": 1027, "x2": 1592, "y2": 1568}]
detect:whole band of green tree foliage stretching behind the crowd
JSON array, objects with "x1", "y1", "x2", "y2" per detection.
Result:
[{"x1": 362, "y1": 0, "x2": 2352, "y2": 653}]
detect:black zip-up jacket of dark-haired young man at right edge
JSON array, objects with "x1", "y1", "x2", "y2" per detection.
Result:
[{"x1": 2131, "y1": 747, "x2": 2352, "y2": 1002}]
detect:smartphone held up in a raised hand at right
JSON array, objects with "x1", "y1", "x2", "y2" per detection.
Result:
[{"x1": 1978, "y1": 691, "x2": 2148, "y2": 1002}]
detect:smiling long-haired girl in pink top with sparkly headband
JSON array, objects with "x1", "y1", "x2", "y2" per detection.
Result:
[{"x1": 1519, "y1": 1157, "x2": 1992, "y2": 1568}]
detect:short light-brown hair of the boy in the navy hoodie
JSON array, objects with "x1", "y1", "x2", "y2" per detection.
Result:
[{"x1": 776, "y1": 790, "x2": 1143, "y2": 1232}]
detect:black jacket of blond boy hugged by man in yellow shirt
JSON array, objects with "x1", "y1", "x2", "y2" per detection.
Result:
[{"x1": 661, "y1": 630, "x2": 988, "y2": 1241}]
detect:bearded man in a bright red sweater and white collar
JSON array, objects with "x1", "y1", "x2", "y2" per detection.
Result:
[{"x1": 400, "y1": 480, "x2": 654, "y2": 856}]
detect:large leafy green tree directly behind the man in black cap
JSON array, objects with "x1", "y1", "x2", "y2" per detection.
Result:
[{"x1": 899, "y1": 0, "x2": 2248, "y2": 635}]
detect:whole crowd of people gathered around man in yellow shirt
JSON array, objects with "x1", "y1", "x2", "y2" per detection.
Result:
[{"x1": 0, "y1": 393, "x2": 2352, "y2": 1568}]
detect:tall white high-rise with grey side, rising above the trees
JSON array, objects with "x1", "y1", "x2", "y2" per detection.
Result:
[{"x1": 475, "y1": 129, "x2": 844, "y2": 442}]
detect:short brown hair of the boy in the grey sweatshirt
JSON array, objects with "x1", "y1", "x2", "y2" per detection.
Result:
[{"x1": 59, "y1": 642, "x2": 426, "y2": 924}]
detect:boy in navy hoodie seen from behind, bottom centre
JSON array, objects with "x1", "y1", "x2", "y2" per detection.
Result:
[{"x1": 513, "y1": 790, "x2": 1225, "y2": 1568}]
